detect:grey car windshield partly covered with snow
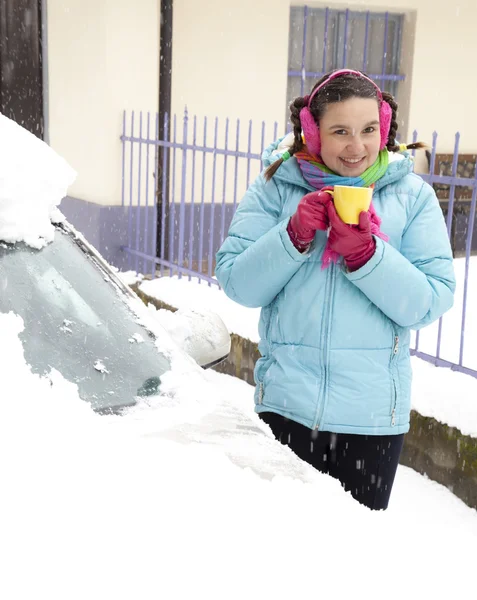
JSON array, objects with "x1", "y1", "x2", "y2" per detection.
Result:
[{"x1": 0, "y1": 227, "x2": 169, "y2": 412}]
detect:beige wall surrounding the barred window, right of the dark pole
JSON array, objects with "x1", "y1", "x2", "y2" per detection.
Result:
[{"x1": 173, "y1": 0, "x2": 477, "y2": 152}]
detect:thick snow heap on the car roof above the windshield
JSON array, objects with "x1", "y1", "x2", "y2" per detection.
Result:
[{"x1": 0, "y1": 114, "x2": 76, "y2": 248}]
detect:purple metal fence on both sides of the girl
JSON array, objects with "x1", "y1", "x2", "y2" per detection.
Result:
[{"x1": 121, "y1": 110, "x2": 477, "y2": 377}]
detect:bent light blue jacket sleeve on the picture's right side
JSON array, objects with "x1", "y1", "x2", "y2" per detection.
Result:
[{"x1": 346, "y1": 182, "x2": 455, "y2": 329}]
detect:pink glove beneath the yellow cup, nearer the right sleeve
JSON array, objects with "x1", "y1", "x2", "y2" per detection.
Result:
[{"x1": 327, "y1": 202, "x2": 376, "y2": 271}]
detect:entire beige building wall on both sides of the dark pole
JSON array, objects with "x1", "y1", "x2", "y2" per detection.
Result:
[{"x1": 47, "y1": 0, "x2": 477, "y2": 205}]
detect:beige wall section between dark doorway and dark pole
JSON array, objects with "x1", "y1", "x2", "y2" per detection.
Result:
[{"x1": 47, "y1": 0, "x2": 159, "y2": 204}]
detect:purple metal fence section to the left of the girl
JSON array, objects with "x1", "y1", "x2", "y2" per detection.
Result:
[{"x1": 121, "y1": 109, "x2": 278, "y2": 285}]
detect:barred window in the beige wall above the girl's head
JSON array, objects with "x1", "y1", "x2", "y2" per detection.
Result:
[{"x1": 287, "y1": 6, "x2": 405, "y2": 113}]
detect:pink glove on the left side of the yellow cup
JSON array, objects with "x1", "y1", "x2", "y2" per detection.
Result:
[{"x1": 287, "y1": 188, "x2": 332, "y2": 252}]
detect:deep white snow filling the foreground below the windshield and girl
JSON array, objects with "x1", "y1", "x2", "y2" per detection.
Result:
[{"x1": 0, "y1": 314, "x2": 477, "y2": 600}]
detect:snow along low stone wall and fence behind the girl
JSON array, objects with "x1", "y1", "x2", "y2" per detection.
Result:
[{"x1": 140, "y1": 270, "x2": 477, "y2": 437}]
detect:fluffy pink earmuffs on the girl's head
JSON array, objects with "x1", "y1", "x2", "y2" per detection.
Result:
[{"x1": 300, "y1": 69, "x2": 393, "y2": 156}]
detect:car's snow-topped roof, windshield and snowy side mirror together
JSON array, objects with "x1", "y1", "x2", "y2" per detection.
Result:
[{"x1": 0, "y1": 114, "x2": 230, "y2": 411}]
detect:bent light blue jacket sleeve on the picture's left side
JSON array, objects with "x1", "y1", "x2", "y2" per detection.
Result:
[{"x1": 216, "y1": 174, "x2": 308, "y2": 307}]
